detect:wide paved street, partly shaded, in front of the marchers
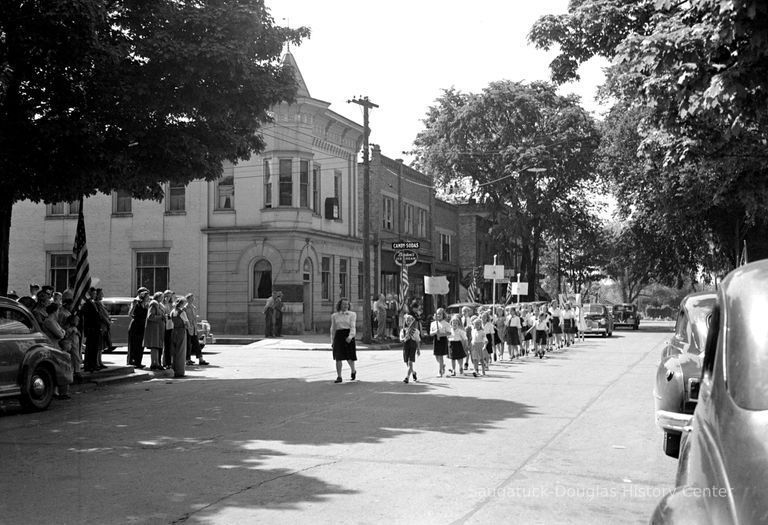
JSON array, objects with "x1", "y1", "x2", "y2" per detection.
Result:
[{"x1": 0, "y1": 323, "x2": 675, "y2": 524}]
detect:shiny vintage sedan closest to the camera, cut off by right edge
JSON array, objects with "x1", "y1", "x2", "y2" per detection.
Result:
[{"x1": 652, "y1": 260, "x2": 768, "y2": 524}]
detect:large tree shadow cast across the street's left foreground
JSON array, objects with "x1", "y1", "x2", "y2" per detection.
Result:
[{"x1": 0, "y1": 377, "x2": 535, "y2": 523}]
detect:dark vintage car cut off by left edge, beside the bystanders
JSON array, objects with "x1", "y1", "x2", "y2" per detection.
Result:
[{"x1": 0, "y1": 297, "x2": 73, "y2": 410}]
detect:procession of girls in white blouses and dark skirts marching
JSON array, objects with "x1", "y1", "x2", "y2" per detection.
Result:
[{"x1": 331, "y1": 298, "x2": 584, "y2": 383}]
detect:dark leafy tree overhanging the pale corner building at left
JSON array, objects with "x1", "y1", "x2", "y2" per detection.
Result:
[{"x1": 0, "y1": 0, "x2": 308, "y2": 293}]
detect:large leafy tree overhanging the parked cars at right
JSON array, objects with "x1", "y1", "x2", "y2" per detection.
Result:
[{"x1": 530, "y1": 0, "x2": 768, "y2": 270}]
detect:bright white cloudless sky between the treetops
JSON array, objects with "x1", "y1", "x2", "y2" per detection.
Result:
[{"x1": 266, "y1": 0, "x2": 606, "y2": 162}]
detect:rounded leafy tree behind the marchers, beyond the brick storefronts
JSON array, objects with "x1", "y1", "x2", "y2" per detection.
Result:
[{"x1": 415, "y1": 81, "x2": 599, "y2": 297}]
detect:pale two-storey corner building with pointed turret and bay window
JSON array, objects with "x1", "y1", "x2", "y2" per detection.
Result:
[{"x1": 9, "y1": 54, "x2": 363, "y2": 333}]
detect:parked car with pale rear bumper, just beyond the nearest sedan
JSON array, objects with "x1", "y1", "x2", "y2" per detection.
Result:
[{"x1": 653, "y1": 292, "x2": 717, "y2": 458}]
